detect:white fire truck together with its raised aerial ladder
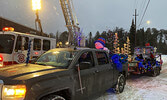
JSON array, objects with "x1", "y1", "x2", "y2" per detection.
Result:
[{"x1": 0, "y1": 0, "x2": 80, "y2": 67}]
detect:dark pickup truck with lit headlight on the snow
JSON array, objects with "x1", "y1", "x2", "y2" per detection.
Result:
[{"x1": 0, "y1": 48, "x2": 128, "y2": 100}]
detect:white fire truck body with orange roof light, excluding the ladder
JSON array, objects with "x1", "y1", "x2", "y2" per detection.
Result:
[{"x1": 0, "y1": 27, "x2": 56, "y2": 67}]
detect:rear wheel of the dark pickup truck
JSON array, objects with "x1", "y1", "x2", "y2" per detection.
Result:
[{"x1": 115, "y1": 74, "x2": 126, "y2": 93}]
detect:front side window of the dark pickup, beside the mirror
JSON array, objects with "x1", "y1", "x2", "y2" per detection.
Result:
[{"x1": 78, "y1": 52, "x2": 95, "y2": 68}]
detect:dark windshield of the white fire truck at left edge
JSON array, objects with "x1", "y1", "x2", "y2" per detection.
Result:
[{"x1": 0, "y1": 34, "x2": 15, "y2": 54}]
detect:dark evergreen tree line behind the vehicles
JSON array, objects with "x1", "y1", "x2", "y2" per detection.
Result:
[{"x1": 50, "y1": 21, "x2": 167, "y2": 54}]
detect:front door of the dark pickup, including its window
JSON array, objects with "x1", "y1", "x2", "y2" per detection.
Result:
[{"x1": 75, "y1": 51, "x2": 96, "y2": 100}]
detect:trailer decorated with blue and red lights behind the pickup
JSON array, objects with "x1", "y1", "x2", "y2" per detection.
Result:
[{"x1": 128, "y1": 46, "x2": 162, "y2": 76}]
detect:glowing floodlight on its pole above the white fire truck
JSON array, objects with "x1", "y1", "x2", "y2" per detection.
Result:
[{"x1": 32, "y1": 0, "x2": 43, "y2": 35}]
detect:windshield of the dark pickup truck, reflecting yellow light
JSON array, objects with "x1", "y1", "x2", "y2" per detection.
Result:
[{"x1": 35, "y1": 51, "x2": 77, "y2": 68}]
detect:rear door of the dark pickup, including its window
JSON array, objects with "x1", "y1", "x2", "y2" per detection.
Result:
[{"x1": 95, "y1": 51, "x2": 114, "y2": 92}]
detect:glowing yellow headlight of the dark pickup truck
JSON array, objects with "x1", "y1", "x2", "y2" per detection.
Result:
[{"x1": 2, "y1": 85, "x2": 26, "y2": 100}]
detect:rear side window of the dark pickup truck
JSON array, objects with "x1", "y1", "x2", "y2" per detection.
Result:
[{"x1": 96, "y1": 52, "x2": 109, "y2": 65}]
